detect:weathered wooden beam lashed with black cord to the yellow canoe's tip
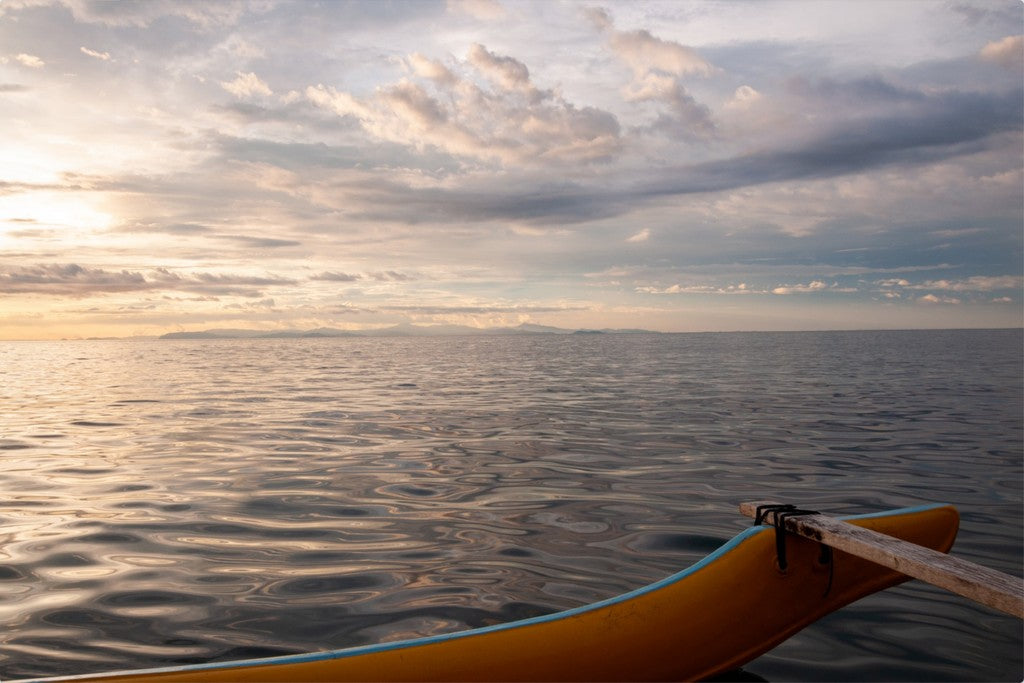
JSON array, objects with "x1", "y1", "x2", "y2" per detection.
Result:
[{"x1": 739, "y1": 501, "x2": 1024, "y2": 618}]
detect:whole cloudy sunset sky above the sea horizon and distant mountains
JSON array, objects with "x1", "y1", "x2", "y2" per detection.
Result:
[{"x1": 0, "y1": 0, "x2": 1024, "y2": 339}]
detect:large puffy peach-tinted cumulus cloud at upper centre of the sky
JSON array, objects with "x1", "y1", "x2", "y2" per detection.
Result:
[{"x1": 305, "y1": 45, "x2": 622, "y2": 165}]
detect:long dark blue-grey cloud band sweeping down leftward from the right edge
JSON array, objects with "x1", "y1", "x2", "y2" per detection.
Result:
[{"x1": 346, "y1": 80, "x2": 1024, "y2": 228}]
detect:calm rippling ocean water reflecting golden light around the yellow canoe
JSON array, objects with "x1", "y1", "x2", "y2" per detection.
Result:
[{"x1": 0, "y1": 330, "x2": 1024, "y2": 681}]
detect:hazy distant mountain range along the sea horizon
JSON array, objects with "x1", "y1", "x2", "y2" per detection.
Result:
[{"x1": 160, "y1": 324, "x2": 654, "y2": 339}]
